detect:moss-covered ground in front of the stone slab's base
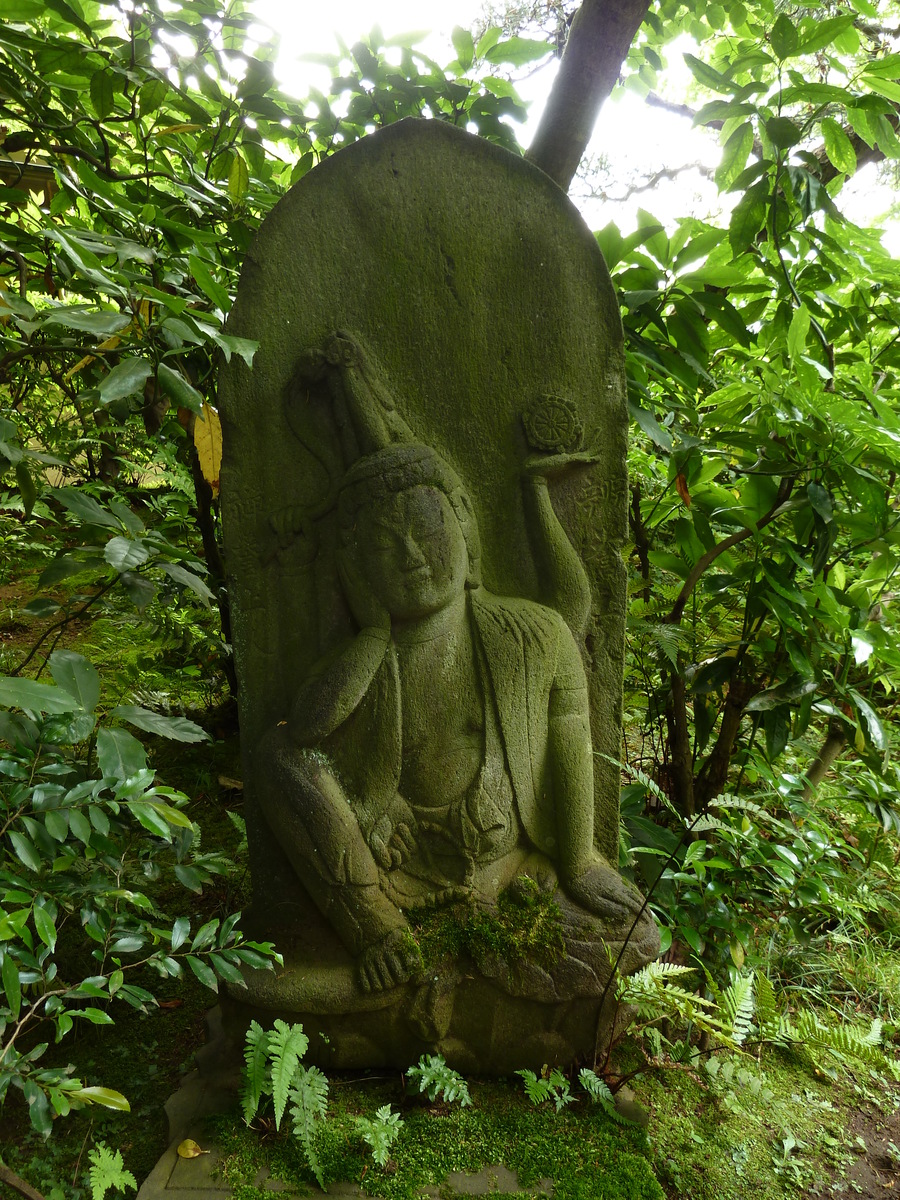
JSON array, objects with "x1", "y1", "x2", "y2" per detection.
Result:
[{"x1": 202, "y1": 1044, "x2": 900, "y2": 1200}]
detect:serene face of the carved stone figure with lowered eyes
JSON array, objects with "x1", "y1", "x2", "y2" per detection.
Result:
[{"x1": 356, "y1": 486, "x2": 469, "y2": 620}]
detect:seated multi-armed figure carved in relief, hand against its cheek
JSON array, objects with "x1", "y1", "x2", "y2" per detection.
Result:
[{"x1": 260, "y1": 332, "x2": 658, "y2": 1001}]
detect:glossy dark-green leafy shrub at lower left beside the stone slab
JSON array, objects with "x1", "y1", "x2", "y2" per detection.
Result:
[{"x1": 0, "y1": 650, "x2": 278, "y2": 1136}]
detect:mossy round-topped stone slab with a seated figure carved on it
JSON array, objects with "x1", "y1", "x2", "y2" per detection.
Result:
[{"x1": 221, "y1": 121, "x2": 656, "y2": 1070}]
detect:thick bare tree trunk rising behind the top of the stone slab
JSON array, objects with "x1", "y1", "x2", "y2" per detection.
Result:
[{"x1": 526, "y1": 0, "x2": 650, "y2": 191}]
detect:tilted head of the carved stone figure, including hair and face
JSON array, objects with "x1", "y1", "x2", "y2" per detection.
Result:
[{"x1": 337, "y1": 443, "x2": 481, "y2": 619}]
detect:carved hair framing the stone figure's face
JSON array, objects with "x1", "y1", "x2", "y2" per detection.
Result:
[{"x1": 337, "y1": 442, "x2": 481, "y2": 588}]
